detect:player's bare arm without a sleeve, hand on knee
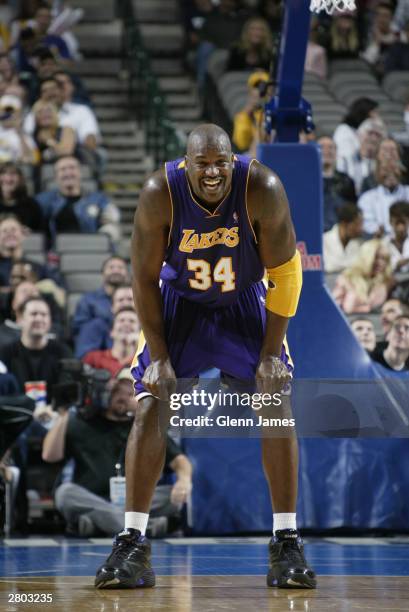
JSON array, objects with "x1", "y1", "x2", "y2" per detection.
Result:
[{"x1": 131, "y1": 171, "x2": 174, "y2": 399}]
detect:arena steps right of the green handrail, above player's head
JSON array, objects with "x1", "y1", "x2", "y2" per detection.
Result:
[{"x1": 133, "y1": 0, "x2": 201, "y2": 134}]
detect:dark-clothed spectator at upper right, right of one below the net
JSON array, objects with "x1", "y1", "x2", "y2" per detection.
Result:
[{"x1": 361, "y1": 2, "x2": 396, "y2": 76}]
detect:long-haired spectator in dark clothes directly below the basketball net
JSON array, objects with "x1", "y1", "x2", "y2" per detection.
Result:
[{"x1": 328, "y1": 12, "x2": 360, "y2": 60}]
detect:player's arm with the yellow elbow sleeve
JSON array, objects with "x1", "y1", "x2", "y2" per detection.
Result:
[{"x1": 248, "y1": 163, "x2": 302, "y2": 391}]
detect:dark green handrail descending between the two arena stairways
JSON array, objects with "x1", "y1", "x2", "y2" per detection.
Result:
[{"x1": 120, "y1": 0, "x2": 184, "y2": 166}]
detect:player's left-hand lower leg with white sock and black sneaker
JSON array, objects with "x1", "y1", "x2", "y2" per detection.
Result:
[{"x1": 95, "y1": 396, "x2": 168, "y2": 588}]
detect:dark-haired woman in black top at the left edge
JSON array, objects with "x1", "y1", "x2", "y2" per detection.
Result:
[{"x1": 0, "y1": 162, "x2": 44, "y2": 232}]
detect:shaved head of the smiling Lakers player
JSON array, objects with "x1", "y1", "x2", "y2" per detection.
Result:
[{"x1": 186, "y1": 123, "x2": 234, "y2": 210}]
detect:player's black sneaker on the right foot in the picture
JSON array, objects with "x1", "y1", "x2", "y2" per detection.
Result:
[{"x1": 267, "y1": 529, "x2": 317, "y2": 589}]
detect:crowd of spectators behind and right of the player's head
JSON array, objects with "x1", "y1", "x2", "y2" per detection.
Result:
[{"x1": 181, "y1": 0, "x2": 409, "y2": 370}]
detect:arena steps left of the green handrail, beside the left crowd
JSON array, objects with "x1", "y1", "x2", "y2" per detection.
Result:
[{"x1": 70, "y1": 0, "x2": 153, "y2": 249}]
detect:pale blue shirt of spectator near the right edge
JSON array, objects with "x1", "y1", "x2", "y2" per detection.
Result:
[{"x1": 358, "y1": 185, "x2": 409, "y2": 234}]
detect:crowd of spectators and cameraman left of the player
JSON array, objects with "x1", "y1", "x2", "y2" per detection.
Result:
[{"x1": 0, "y1": 0, "x2": 191, "y2": 536}]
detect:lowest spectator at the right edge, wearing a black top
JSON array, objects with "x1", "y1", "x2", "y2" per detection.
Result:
[{"x1": 372, "y1": 315, "x2": 409, "y2": 376}]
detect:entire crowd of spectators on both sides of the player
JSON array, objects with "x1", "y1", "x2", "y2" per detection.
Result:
[{"x1": 0, "y1": 0, "x2": 409, "y2": 535}]
